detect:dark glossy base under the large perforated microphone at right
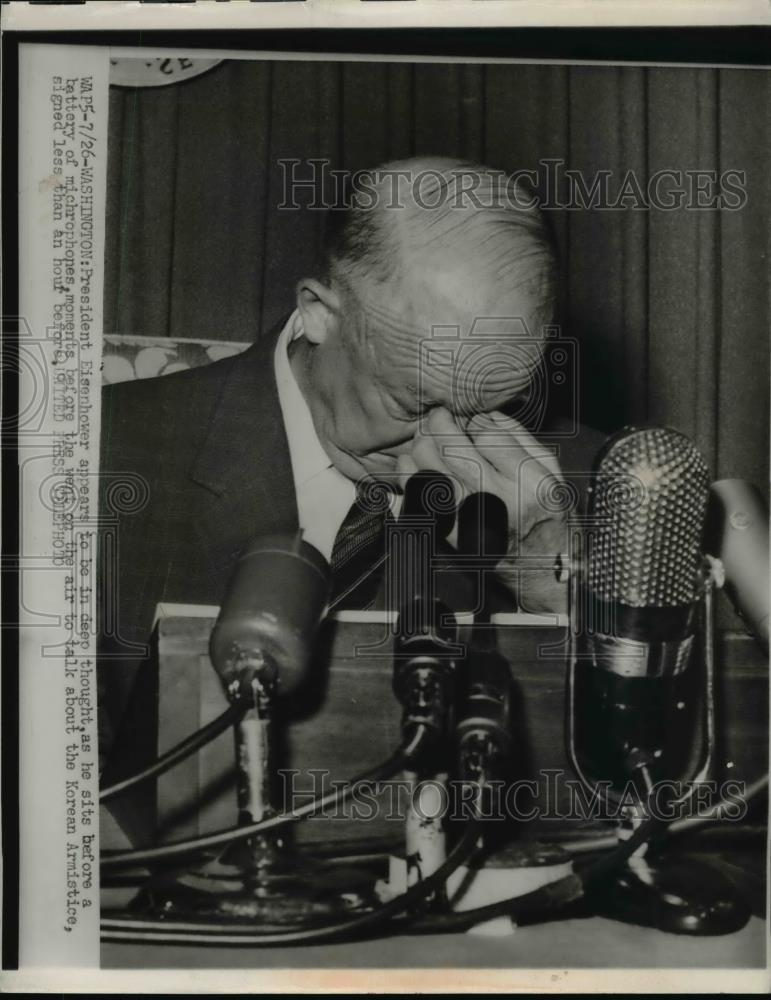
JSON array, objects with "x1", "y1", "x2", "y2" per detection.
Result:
[{"x1": 589, "y1": 856, "x2": 751, "y2": 937}]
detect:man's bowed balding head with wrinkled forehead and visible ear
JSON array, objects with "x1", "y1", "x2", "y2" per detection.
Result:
[{"x1": 293, "y1": 159, "x2": 555, "y2": 476}]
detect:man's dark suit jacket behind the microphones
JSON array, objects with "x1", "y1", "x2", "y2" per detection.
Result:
[{"x1": 99, "y1": 323, "x2": 598, "y2": 754}]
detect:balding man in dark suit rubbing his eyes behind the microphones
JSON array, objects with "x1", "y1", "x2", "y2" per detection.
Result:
[{"x1": 100, "y1": 160, "x2": 600, "y2": 764}]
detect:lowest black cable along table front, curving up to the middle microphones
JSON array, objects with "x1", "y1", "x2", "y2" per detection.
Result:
[{"x1": 101, "y1": 819, "x2": 479, "y2": 946}]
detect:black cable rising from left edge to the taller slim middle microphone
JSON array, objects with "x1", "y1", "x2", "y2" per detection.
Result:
[{"x1": 101, "y1": 726, "x2": 428, "y2": 871}]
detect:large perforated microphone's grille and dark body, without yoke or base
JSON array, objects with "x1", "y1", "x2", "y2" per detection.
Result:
[{"x1": 571, "y1": 427, "x2": 708, "y2": 787}]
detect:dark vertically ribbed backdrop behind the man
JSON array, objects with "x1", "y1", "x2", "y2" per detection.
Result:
[{"x1": 105, "y1": 61, "x2": 771, "y2": 490}]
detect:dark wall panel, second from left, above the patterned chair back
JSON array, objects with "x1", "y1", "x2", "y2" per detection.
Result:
[{"x1": 169, "y1": 62, "x2": 270, "y2": 340}]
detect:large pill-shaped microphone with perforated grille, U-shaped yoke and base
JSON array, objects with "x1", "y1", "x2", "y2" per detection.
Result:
[{"x1": 567, "y1": 427, "x2": 750, "y2": 934}]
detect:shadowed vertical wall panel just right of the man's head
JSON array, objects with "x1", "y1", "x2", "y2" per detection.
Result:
[{"x1": 567, "y1": 67, "x2": 647, "y2": 430}]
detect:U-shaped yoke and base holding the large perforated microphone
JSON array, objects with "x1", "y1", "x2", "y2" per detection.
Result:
[{"x1": 566, "y1": 521, "x2": 750, "y2": 935}]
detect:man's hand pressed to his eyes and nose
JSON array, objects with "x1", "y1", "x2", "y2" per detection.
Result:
[{"x1": 398, "y1": 407, "x2": 567, "y2": 612}]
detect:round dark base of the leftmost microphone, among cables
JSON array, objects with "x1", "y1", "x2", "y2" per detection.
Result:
[{"x1": 129, "y1": 845, "x2": 377, "y2": 933}]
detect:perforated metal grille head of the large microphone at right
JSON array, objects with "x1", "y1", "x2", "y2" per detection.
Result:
[{"x1": 588, "y1": 427, "x2": 709, "y2": 608}]
